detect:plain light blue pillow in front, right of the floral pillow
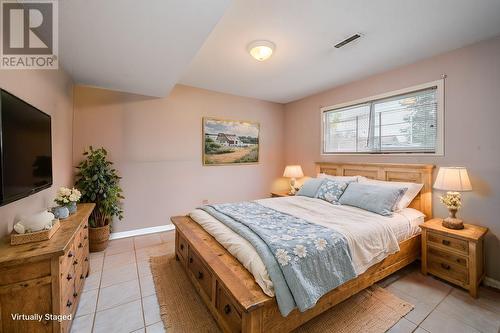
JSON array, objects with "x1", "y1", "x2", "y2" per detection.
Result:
[{"x1": 339, "y1": 183, "x2": 406, "y2": 216}]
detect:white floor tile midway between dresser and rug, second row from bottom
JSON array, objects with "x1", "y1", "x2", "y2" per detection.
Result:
[{"x1": 97, "y1": 280, "x2": 141, "y2": 311}]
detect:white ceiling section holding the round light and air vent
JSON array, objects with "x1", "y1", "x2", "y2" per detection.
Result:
[{"x1": 182, "y1": 0, "x2": 500, "y2": 103}]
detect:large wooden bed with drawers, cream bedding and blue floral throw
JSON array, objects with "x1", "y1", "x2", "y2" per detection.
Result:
[{"x1": 172, "y1": 163, "x2": 433, "y2": 332}]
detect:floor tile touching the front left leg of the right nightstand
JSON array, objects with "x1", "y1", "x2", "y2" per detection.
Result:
[{"x1": 390, "y1": 272, "x2": 452, "y2": 305}]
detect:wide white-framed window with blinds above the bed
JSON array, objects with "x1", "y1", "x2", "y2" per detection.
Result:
[{"x1": 322, "y1": 81, "x2": 443, "y2": 154}]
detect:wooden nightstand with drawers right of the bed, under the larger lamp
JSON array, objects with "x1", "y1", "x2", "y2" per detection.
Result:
[{"x1": 420, "y1": 219, "x2": 488, "y2": 297}]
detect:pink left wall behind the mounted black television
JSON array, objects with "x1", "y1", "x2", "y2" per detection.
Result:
[{"x1": 0, "y1": 70, "x2": 73, "y2": 236}]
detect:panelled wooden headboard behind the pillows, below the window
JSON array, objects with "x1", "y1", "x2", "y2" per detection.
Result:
[{"x1": 315, "y1": 162, "x2": 434, "y2": 220}]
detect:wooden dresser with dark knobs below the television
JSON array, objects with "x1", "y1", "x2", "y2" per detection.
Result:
[{"x1": 0, "y1": 204, "x2": 95, "y2": 333}]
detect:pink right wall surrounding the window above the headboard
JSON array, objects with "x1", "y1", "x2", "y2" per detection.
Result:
[{"x1": 285, "y1": 37, "x2": 500, "y2": 280}]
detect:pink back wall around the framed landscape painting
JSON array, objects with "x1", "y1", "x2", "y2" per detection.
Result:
[{"x1": 73, "y1": 85, "x2": 284, "y2": 232}]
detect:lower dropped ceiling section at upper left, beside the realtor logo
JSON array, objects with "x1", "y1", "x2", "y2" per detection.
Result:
[{"x1": 59, "y1": 0, "x2": 230, "y2": 97}]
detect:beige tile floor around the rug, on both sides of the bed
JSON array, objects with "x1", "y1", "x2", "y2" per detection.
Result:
[{"x1": 71, "y1": 232, "x2": 500, "y2": 333}]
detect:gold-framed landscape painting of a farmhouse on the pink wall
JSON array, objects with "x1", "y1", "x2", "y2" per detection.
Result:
[{"x1": 203, "y1": 118, "x2": 260, "y2": 165}]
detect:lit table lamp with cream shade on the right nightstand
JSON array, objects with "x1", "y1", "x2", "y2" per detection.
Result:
[{"x1": 434, "y1": 167, "x2": 472, "y2": 229}]
